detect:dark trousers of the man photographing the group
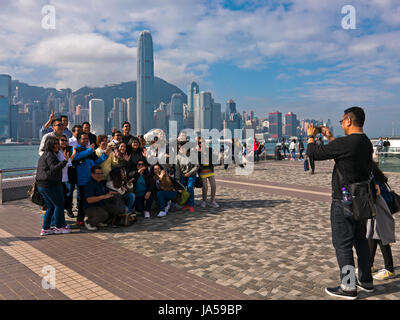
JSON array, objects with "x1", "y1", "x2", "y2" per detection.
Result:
[{"x1": 331, "y1": 199, "x2": 372, "y2": 290}]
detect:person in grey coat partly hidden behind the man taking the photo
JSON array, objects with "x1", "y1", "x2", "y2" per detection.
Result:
[{"x1": 367, "y1": 162, "x2": 396, "y2": 280}]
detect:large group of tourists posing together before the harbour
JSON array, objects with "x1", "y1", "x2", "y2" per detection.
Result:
[{"x1": 36, "y1": 114, "x2": 219, "y2": 235}]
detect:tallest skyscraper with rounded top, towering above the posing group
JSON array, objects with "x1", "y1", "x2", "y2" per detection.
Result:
[{"x1": 136, "y1": 30, "x2": 154, "y2": 135}]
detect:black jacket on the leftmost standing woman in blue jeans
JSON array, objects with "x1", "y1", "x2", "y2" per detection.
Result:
[{"x1": 36, "y1": 151, "x2": 67, "y2": 188}]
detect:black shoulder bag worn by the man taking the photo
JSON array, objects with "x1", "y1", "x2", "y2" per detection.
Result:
[{"x1": 336, "y1": 166, "x2": 376, "y2": 221}]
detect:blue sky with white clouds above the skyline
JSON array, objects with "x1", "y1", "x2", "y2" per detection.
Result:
[{"x1": 0, "y1": 0, "x2": 400, "y2": 136}]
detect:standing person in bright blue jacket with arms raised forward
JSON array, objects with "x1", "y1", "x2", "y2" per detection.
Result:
[{"x1": 72, "y1": 133, "x2": 111, "y2": 226}]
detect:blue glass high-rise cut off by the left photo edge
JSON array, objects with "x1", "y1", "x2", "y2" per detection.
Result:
[{"x1": 0, "y1": 74, "x2": 11, "y2": 139}]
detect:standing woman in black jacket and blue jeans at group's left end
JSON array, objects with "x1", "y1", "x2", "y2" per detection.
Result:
[{"x1": 35, "y1": 137, "x2": 71, "y2": 236}]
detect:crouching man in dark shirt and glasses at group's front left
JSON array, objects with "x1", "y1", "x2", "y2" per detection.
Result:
[{"x1": 84, "y1": 166, "x2": 117, "y2": 231}]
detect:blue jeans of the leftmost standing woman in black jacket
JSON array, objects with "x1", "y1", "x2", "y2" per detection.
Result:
[{"x1": 38, "y1": 184, "x2": 65, "y2": 230}]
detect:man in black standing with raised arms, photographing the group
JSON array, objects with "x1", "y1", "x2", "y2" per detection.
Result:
[{"x1": 307, "y1": 107, "x2": 374, "y2": 299}]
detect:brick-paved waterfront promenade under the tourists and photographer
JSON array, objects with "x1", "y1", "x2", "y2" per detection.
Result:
[{"x1": 0, "y1": 161, "x2": 400, "y2": 300}]
